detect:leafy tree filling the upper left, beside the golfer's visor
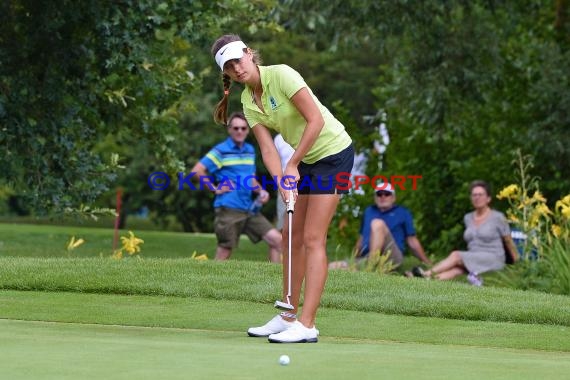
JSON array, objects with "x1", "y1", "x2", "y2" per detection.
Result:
[{"x1": 0, "y1": 0, "x2": 280, "y2": 211}]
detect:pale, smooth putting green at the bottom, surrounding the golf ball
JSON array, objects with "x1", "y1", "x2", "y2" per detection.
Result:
[{"x1": 0, "y1": 319, "x2": 570, "y2": 380}]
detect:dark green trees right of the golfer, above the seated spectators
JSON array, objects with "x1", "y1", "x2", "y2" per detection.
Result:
[{"x1": 277, "y1": 0, "x2": 570, "y2": 256}]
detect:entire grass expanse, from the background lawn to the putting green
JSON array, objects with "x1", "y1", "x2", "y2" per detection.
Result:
[{"x1": 4, "y1": 221, "x2": 570, "y2": 380}]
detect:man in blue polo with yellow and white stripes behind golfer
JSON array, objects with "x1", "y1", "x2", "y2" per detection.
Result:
[{"x1": 192, "y1": 112, "x2": 281, "y2": 263}]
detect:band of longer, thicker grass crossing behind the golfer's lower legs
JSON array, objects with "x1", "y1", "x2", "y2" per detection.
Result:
[{"x1": 0, "y1": 257, "x2": 570, "y2": 326}]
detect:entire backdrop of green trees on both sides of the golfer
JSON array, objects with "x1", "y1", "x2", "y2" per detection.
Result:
[{"x1": 0, "y1": 0, "x2": 570, "y2": 246}]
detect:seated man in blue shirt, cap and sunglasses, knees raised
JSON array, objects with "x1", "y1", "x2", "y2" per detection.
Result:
[{"x1": 329, "y1": 183, "x2": 430, "y2": 269}]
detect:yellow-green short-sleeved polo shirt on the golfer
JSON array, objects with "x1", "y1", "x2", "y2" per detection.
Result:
[{"x1": 241, "y1": 65, "x2": 352, "y2": 164}]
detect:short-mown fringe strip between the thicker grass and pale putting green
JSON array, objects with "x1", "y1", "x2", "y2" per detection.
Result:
[{"x1": 0, "y1": 290, "x2": 570, "y2": 352}]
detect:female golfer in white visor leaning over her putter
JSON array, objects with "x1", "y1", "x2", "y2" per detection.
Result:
[{"x1": 212, "y1": 35, "x2": 354, "y2": 343}]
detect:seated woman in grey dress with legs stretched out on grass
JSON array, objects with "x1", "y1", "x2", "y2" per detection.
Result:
[{"x1": 408, "y1": 181, "x2": 518, "y2": 286}]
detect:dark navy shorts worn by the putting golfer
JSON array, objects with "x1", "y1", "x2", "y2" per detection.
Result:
[{"x1": 297, "y1": 144, "x2": 354, "y2": 194}]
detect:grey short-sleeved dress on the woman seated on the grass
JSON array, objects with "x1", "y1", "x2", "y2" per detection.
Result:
[{"x1": 459, "y1": 210, "x2": 511, "y2": 274}]
